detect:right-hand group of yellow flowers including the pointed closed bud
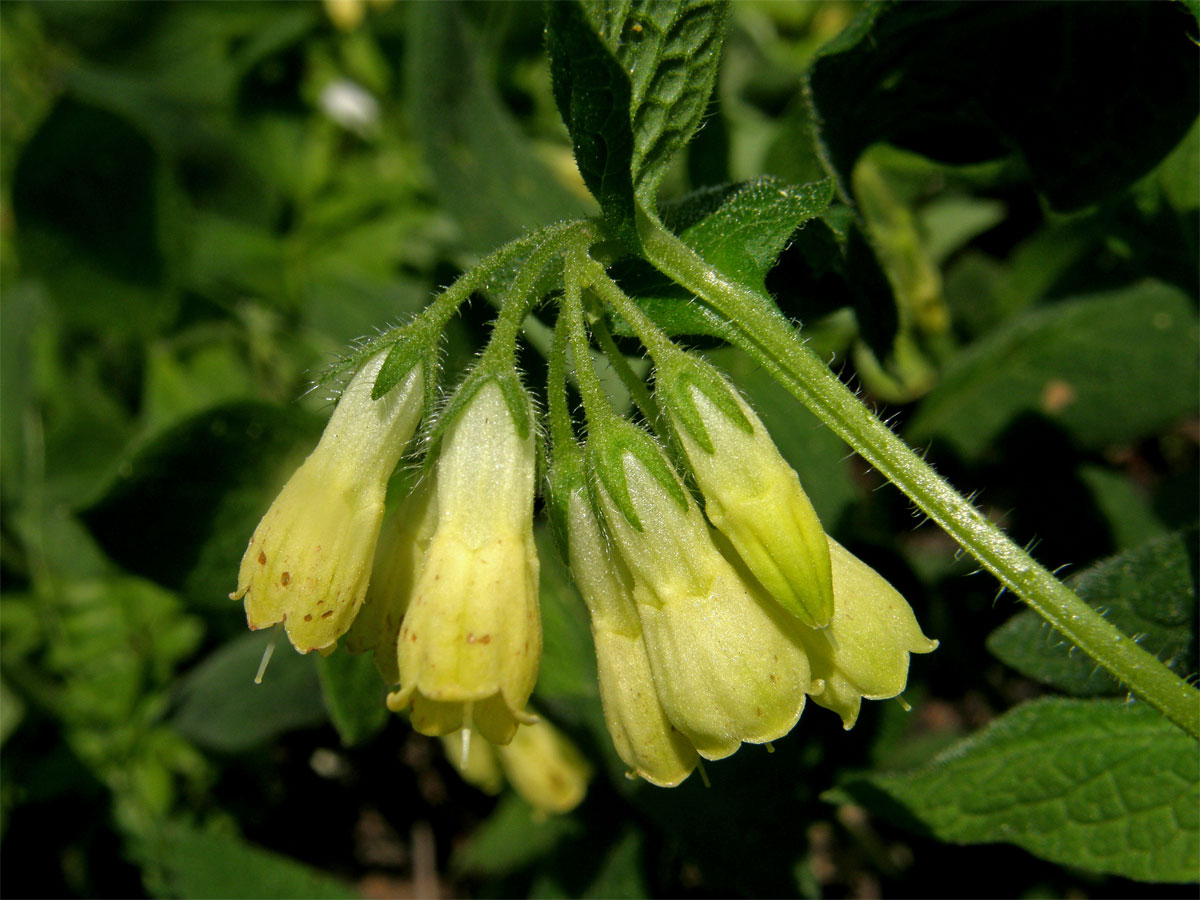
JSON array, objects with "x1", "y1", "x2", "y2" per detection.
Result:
[{"x1": 551, "y1": 300, "x2": 936, "y2": 785}]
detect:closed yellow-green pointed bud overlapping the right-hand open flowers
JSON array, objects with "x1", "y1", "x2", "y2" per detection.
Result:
[{"x1": 656, "y1": 353, "x2": 833, "y2": 628}]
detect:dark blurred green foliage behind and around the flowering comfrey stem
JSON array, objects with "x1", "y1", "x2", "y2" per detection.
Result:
[{"x1": 0, "y1": 0, "x2": 1200, "y2": 898}]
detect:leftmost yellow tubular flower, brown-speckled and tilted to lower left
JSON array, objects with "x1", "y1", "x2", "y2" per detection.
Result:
[{"x1": 230, "y1": 353, "x2": 424, "y2": 653}]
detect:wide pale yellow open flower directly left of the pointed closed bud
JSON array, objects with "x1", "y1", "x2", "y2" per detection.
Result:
[{"x1": 598, "y1": 452, "x2": 810, "y2": 760}]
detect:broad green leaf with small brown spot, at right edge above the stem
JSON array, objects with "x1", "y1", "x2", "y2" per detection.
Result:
[{"x1": 907, "y1": 281, "x2": 1200, "y2": 460}]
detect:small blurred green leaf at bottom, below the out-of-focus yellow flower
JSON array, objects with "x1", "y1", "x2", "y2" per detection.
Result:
[{"x1": 450, "y1": 793, "x2": 580, "y2": 877}]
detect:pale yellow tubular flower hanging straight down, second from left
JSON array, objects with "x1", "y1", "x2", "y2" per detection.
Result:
[{"x1": 388, "y1": 380, "x2": 541, "y2": 744}]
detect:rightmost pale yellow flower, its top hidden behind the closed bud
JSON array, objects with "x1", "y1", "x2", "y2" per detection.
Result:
[{"x1": 805, "y1": 538, "x2": 937, "y2": 730}]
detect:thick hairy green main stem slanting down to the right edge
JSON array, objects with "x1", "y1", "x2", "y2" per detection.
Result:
[{"x1": 638, "y1": 217, "x2": 1200, "y2": 738}]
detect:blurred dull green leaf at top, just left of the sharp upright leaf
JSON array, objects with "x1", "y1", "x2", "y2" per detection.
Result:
[{"x1": 417, "y1": 4, "x2": 588, "y2": 253}]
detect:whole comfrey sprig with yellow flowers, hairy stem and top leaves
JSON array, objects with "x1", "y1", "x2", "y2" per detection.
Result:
[{"x1": 233, "y1": 1, "x2": 1200, "y2": 811}]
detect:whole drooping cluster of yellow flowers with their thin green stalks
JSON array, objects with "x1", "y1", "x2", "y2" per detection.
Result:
[{"x1": 233, "y1": 236, "x2": 936, "y2": 806}]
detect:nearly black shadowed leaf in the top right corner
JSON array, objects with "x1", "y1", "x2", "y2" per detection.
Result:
[{"x1": 805, "y1": 2, "x2": 1200, "y2": 210}]
